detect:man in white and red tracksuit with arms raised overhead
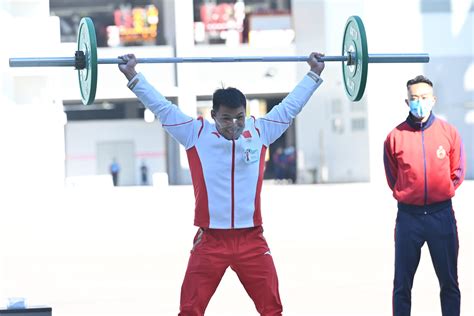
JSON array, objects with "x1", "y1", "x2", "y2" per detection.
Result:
[{"x1": 119, "y1": 53, "x2": 324, "y2": 316}]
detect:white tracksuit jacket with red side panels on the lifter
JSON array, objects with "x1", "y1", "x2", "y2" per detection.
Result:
[{"x1": 128, "y1": 72, "x2": 322, "y2": 229}]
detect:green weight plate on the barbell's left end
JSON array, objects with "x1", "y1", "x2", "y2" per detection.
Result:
[{"x1": 77, "y1": 17, "x2": 97, "y2": 105}]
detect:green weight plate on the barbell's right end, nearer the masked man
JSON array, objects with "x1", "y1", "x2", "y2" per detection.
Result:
[{"x1": 342, "y1": 16, "x2": 369, "y2": 101}]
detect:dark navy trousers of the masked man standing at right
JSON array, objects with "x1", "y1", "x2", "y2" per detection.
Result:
[{"x1": 393, "y1": 201, "x2": 461, "y2": 316}]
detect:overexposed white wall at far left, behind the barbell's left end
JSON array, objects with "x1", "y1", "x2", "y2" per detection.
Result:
[{"x1": 0, "y1": 0, "x2": 65, "y2": 189}]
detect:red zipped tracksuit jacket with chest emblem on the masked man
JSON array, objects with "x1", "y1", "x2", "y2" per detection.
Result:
[{"x1": 384, "y1": 113, "x2": 466, "y2": 206}]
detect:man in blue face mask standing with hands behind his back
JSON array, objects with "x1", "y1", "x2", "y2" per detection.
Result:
[{"x1": 384, "y1": 76, "x2": 465, "y2": 316}]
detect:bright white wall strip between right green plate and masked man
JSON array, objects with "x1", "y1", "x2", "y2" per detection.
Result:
[{"x1": 363, "y1": 1, "x2": 430, "y2": 185}]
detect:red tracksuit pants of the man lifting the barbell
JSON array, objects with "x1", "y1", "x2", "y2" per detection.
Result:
[{"x1": 179, "y1": 226, "x2": 283, "y2": 316}]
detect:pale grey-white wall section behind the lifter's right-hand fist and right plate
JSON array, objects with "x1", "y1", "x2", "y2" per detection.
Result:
[{"x1": 292, "y1": 0, "x2": 370, "y2": 182}]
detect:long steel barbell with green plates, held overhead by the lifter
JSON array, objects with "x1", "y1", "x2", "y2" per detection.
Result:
[{"x1": 9, "y1": 16, "x2": 430, "y2": 105}]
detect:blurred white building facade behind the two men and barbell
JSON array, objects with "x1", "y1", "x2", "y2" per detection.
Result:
[{"x1": 0, "y1": 0, "x2": 474, "y2": 185}]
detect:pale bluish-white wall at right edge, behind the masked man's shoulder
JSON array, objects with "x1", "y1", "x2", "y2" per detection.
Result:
[{"x1": 422, "y1": 10, "x2": 474, "y2": 179}]
